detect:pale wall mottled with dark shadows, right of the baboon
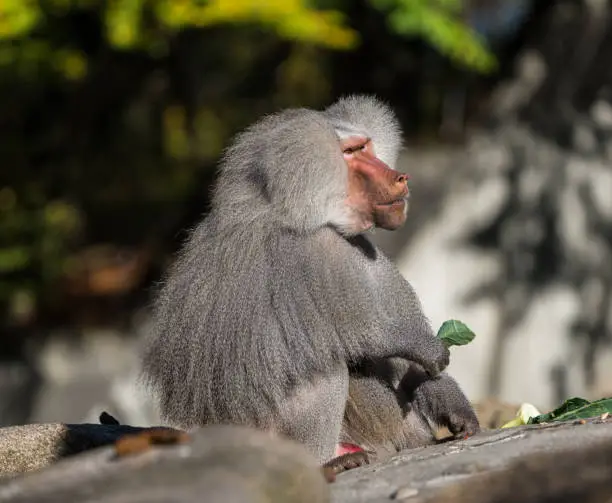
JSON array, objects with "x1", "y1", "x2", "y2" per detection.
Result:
[{"x1": 375, "y1": 121, "x2": 612, "y2": 408}]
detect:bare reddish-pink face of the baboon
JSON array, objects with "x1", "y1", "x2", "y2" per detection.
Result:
[{"x1": 340, "y1": 136, "x2": 408, "y2": 231}]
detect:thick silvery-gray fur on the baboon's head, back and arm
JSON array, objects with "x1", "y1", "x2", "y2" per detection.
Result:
[{"x1": 143, "y1": 96, "x2": 478, "y2": 461}]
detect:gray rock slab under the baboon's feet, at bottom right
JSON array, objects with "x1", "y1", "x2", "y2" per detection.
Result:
[{"x1": 332, "y1": 420, "x2": 612, "y2": 503}]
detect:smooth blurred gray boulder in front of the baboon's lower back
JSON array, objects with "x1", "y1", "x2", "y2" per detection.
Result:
[{"x1": 0, "y1": 426, "x2": 329, "y2": 503}]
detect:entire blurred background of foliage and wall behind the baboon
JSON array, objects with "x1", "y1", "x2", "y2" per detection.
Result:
[{"x1": 0, "y1": 0, "x2": 612, "y2": 425}]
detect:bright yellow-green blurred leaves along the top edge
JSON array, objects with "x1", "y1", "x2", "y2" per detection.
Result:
[{"x1": 0, "y1": 0, "x2": 495, "y2": 79}]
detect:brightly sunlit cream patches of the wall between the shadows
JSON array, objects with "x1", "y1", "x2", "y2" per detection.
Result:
[{"x1": 374, "y1": 145, "x2": 612, "y2": 409}]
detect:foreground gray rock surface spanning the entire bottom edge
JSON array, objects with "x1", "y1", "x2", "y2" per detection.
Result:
[{"x1": 0, "y1": 418, "x2": 612, "y2": 503}]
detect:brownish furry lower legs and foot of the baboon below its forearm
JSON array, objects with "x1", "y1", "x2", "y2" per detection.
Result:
[{"x1": 341, "y1": 358, "x2": 479, "y2": 459}]
